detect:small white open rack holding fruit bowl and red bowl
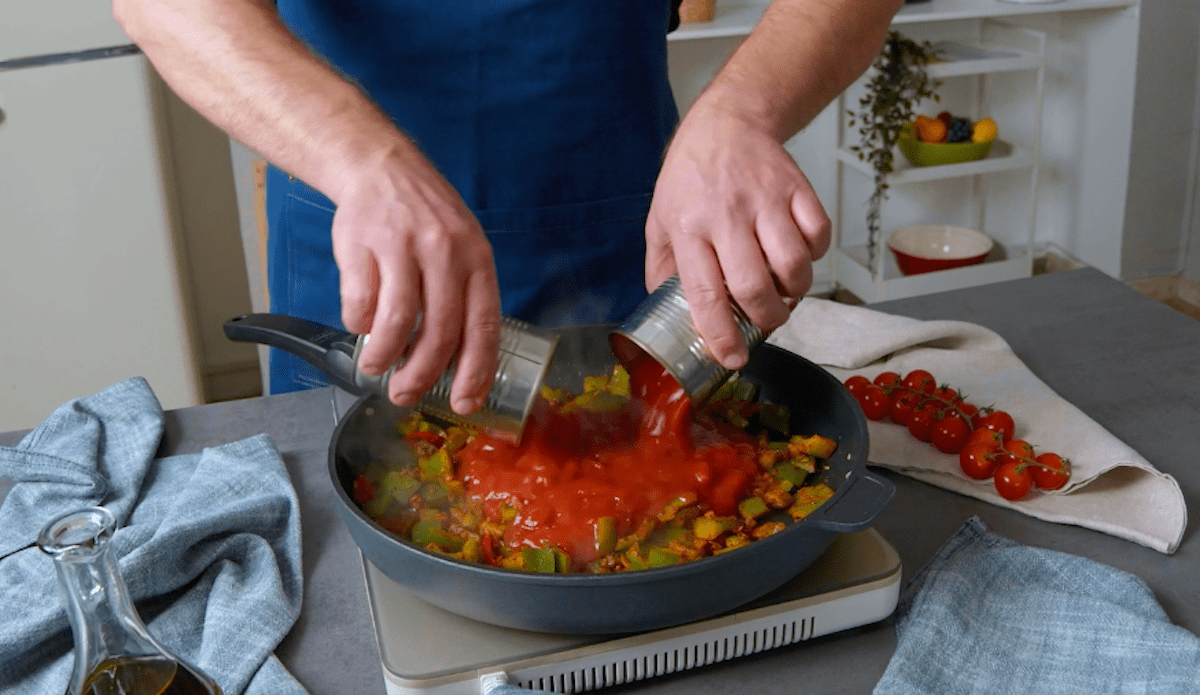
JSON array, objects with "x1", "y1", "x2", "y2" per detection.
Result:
[{"x1": 833, "y1": 20, "x2": 1046, "y2": 301}]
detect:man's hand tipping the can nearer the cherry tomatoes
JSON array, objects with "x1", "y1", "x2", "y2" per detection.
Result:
[{"x1": 646, "y1": 103, "x2": 830, "y2": 370}]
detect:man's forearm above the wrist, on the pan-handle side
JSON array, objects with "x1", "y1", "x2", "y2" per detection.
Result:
[{"x1": 113, "y1": 0, "x2": 410, "y2": 202}]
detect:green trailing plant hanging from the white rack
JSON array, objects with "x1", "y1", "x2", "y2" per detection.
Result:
[{"x1": 850, "y1": 31, "x2": 941, "y2": 272}]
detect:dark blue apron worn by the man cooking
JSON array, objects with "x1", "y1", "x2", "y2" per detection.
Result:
[{"x1": 266, "y1": 0, "x2": 678, "y2": 393}]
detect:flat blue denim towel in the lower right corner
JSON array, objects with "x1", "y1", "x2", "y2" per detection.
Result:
[{"x1": 875, "y1": 517, "x2": 1200, "y2": 695}]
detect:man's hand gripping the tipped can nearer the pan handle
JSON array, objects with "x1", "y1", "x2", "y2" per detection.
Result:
[{"x1": 332, "y1": 150, "x2": 500, "y2": 415}]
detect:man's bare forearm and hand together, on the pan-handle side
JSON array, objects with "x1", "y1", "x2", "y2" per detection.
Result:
[{"x1": 113, "y1": 0, "x2": 500, "y2": 414}]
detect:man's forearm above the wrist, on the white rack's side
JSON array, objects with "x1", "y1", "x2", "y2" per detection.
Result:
[{"x1": 697, "y1": 0, "x2": 902, "y2": 142}]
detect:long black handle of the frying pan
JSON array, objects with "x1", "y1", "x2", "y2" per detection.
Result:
[{"x1": 224, "y1": 313, "x2": 368, "y2": 396}]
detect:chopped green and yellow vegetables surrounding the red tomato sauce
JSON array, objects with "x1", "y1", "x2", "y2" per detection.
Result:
[{"x1": 352, "y1": 367, "x2": 836, "y2": 574}]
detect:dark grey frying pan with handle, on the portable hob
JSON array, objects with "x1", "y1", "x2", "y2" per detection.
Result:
[{"x1": 226, "y1": 314, "x2": 894, "y2": 635}]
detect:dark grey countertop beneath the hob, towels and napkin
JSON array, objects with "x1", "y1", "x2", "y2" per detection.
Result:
[{"x1": 9, "y1": 269, "x2": 1200, "y2": 695}]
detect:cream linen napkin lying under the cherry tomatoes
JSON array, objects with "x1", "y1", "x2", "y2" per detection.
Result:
[{"x1": 768, "y1": 298, "x2": 1187, "y2": 553}]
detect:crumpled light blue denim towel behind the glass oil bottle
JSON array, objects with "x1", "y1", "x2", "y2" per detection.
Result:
[{"x1": 0, "y1": 378, "x2": 305, "y2": 695}]
